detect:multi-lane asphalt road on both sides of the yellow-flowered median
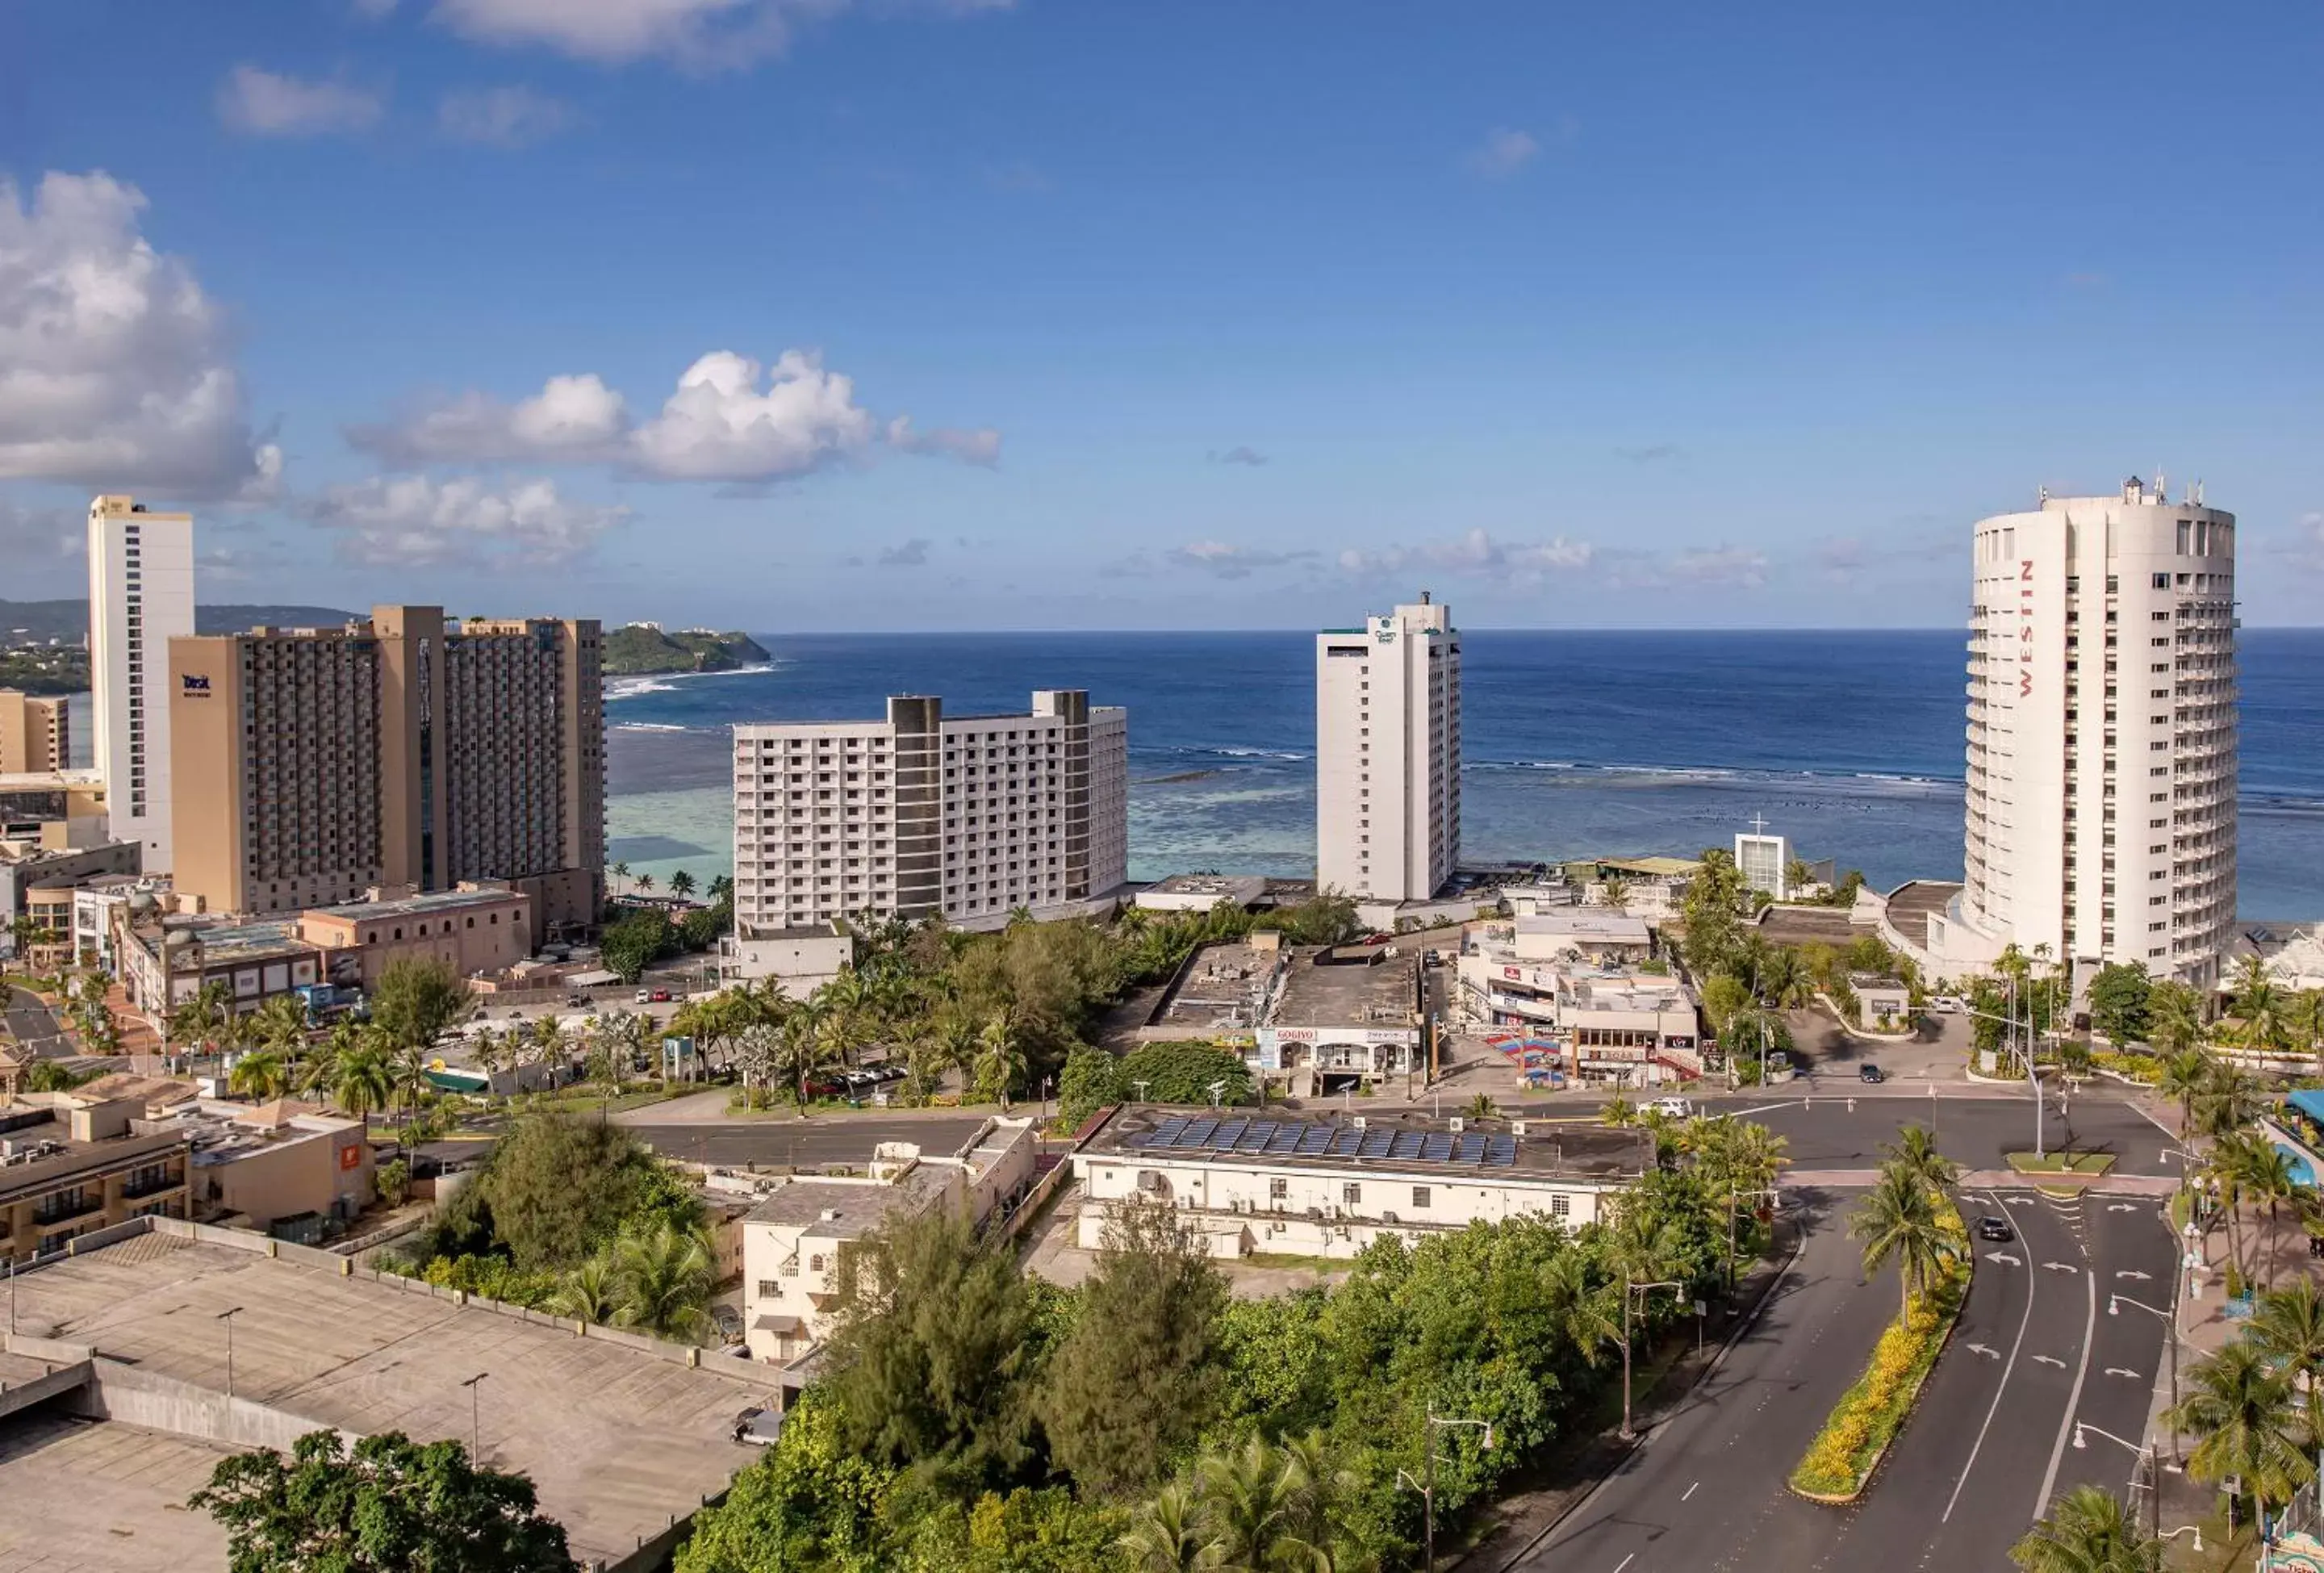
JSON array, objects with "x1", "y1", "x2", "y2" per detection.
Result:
[{"x1": 1520, "y1": 1192, "x2": 2171, "y2": 1573}]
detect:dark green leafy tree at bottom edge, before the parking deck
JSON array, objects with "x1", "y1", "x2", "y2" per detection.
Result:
[{"x1": 186, "y1": 1431, "x2": 574, "y2": 1573}]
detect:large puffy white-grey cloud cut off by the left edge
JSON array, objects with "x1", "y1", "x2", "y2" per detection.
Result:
[{"x1": 0, "y1": 172, "x2": 281, "y2": 497}]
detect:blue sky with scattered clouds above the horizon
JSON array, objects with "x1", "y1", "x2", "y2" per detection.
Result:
[{"x1": 0, "y1": 0, "x2": 2324, "y2": 630}]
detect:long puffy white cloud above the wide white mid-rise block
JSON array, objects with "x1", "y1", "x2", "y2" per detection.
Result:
[{"x1": 346, "y1": 349, "x2": 1001, "y2": 483}]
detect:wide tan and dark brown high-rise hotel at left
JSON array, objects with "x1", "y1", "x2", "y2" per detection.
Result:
[{"x1": 169, "y1": 606, "x2": 604, "y2": 931}]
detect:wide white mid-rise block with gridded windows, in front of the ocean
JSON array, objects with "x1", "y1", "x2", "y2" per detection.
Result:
[{"x1": 734, "y1": 688, "x2": 1130, "y2": 930}]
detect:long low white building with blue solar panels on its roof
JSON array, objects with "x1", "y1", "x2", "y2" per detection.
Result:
[{"x1": 1074, "y1": 1103, "x2": 1655, "y2": 1257}]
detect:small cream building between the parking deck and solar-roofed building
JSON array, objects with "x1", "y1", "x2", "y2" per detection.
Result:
[{"x1": 742, "y1": 1120, "x2": 1039, "y2": 1366}]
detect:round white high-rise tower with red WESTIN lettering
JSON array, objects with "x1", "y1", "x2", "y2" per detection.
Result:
[{"x1": 1929, "y1": 476, "x2": 2236, "y2": 985}]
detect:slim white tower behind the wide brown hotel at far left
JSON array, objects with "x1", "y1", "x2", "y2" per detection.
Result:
[{"x1": 88, "y1": 495, "x2": 193, "y2": 873}]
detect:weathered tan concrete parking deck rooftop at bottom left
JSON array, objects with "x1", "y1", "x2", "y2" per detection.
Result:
[{"x1": 0, "y1": 1224, "x2": 774, "y2": 1568}]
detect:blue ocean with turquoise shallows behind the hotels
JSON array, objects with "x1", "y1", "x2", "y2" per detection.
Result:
[{"x1": 607, "y1": 630, "x2": 2324, "y2": 918}]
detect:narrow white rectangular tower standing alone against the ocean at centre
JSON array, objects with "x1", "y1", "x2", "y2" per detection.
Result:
[{"x1": 1315, "y1": 590, "x2": 1460, "y2": 902}]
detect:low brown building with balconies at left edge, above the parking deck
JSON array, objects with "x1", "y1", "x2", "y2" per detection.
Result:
[{"x1": 0, "y1": 1092, "x2": 193, "y2": 1261}]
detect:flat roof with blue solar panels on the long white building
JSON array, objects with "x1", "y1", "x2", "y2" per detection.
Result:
[{"x1": 1076, "y1": 1103, "x2": 1655, "y2": 1182}]
